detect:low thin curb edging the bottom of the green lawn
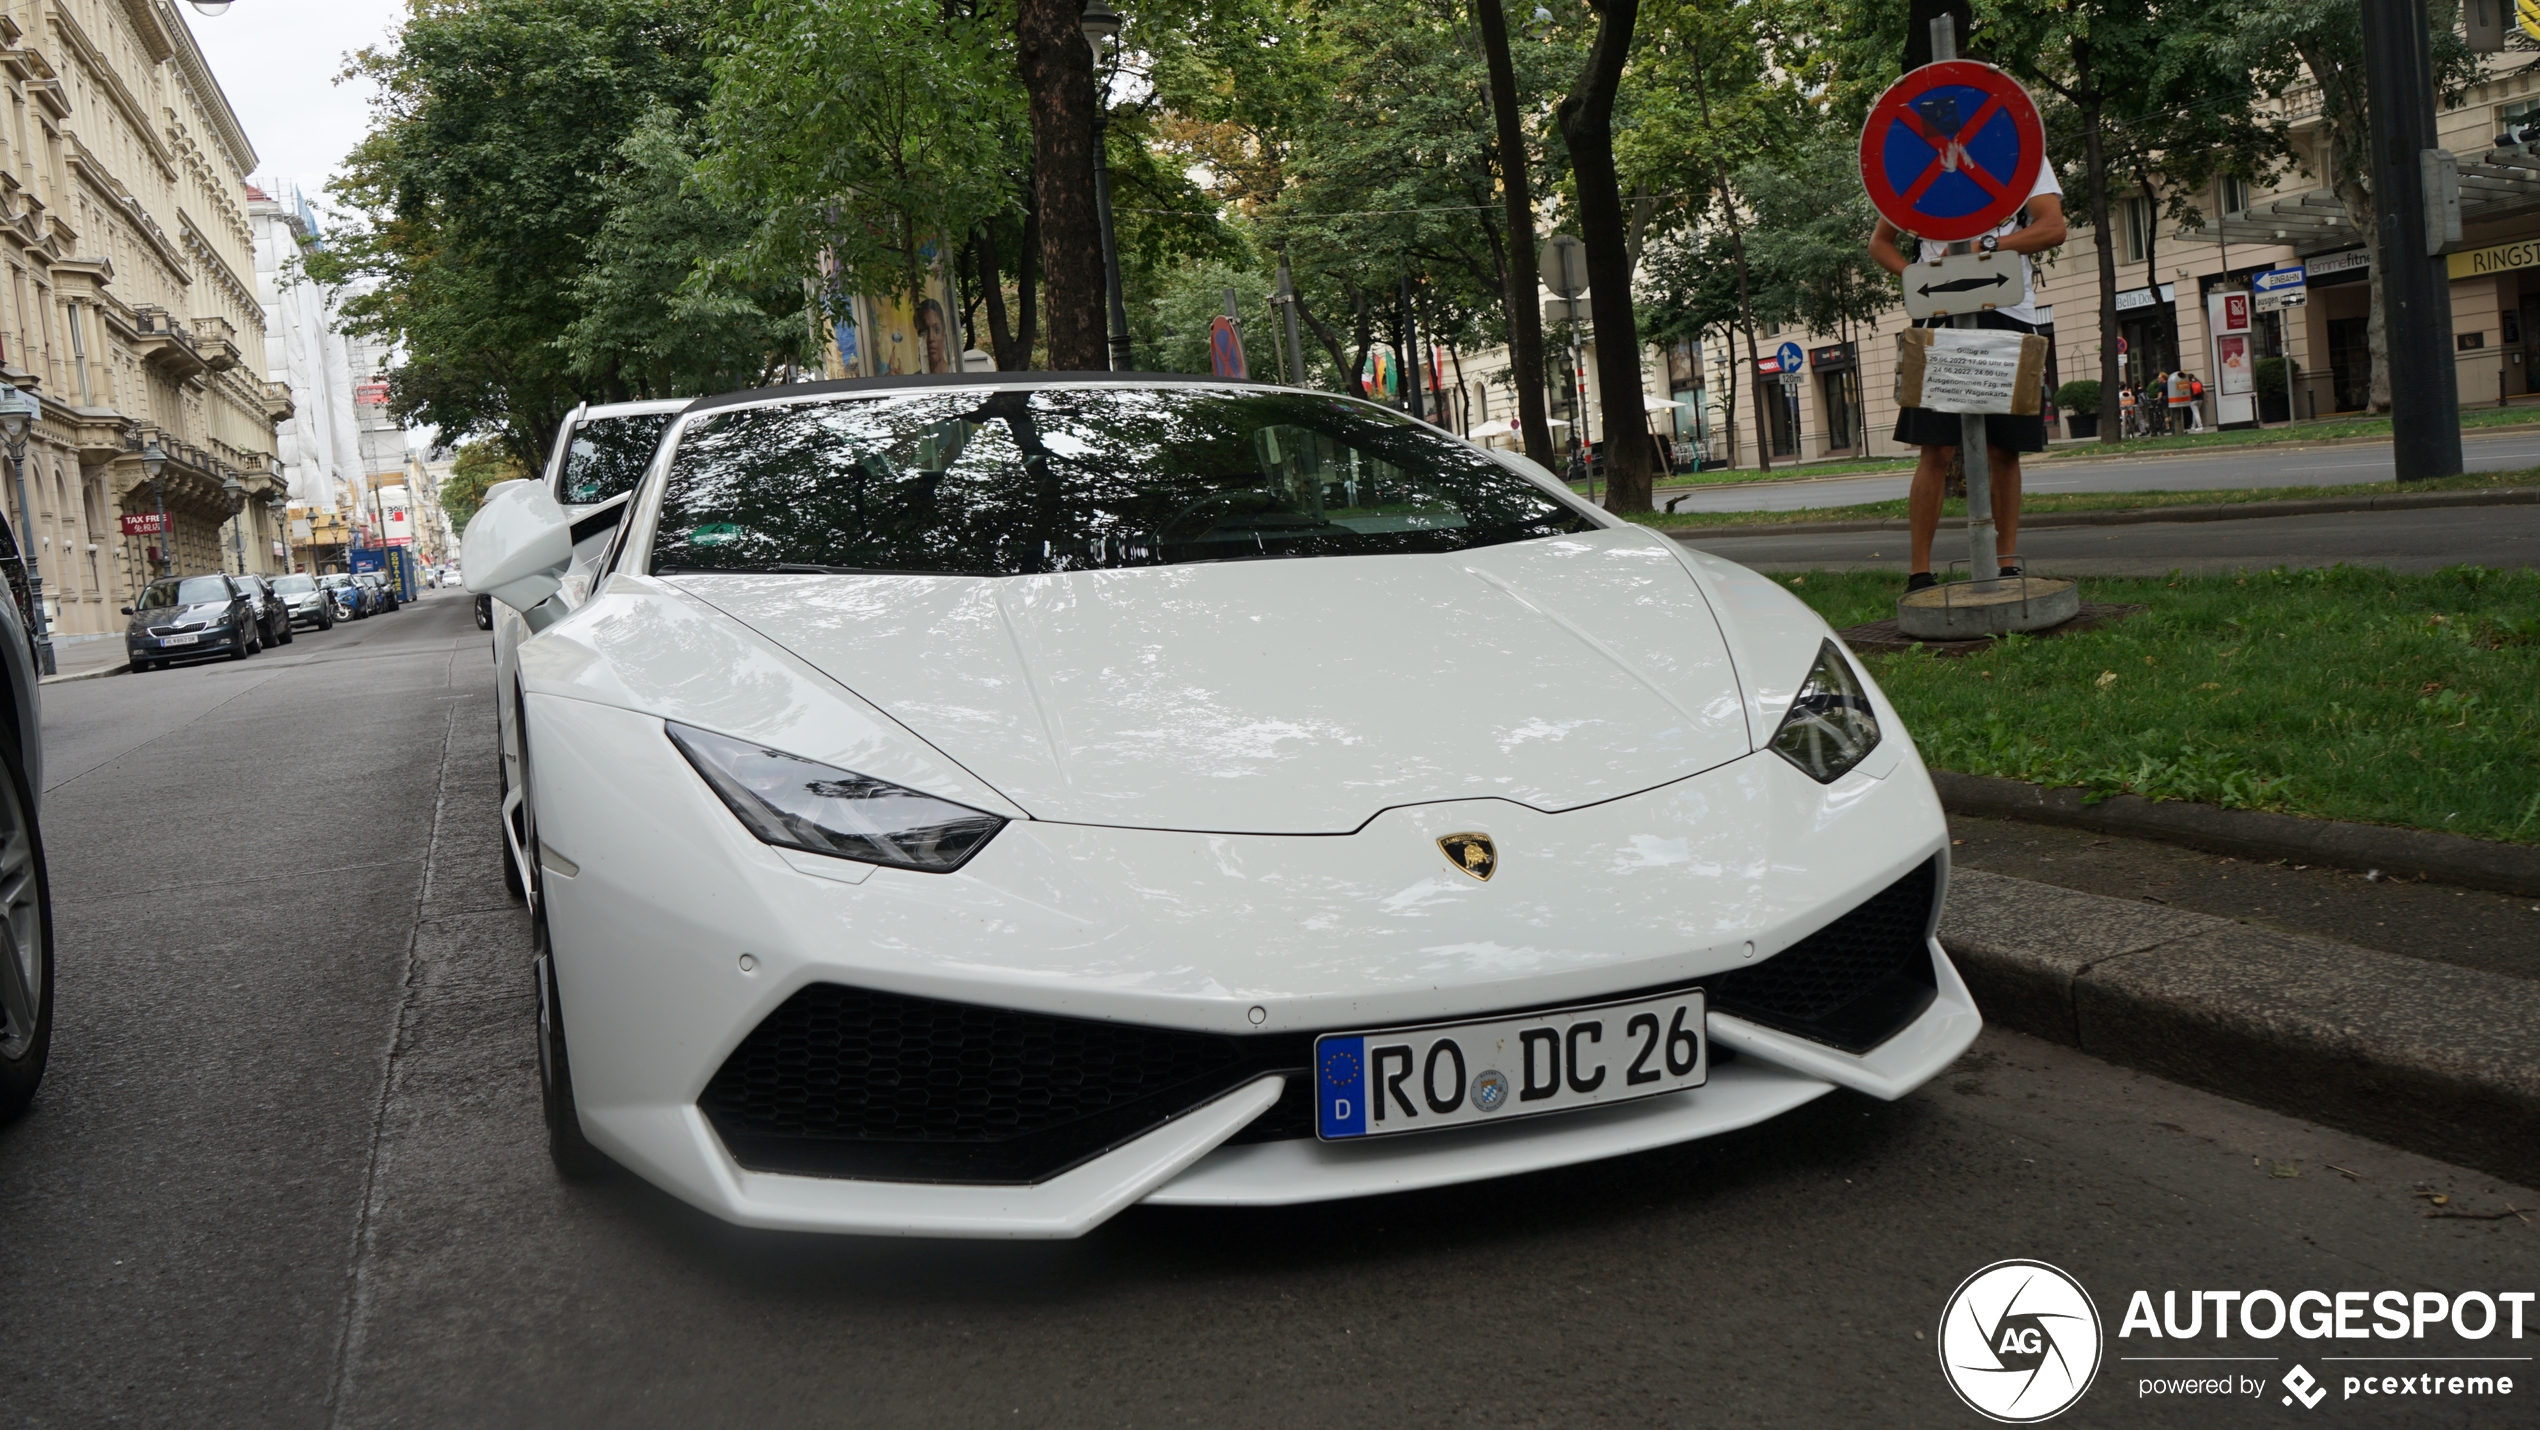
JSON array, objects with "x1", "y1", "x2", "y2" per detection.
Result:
[{"x1": 1930, "y1": 770, "x2": 2540, "y2": 897}]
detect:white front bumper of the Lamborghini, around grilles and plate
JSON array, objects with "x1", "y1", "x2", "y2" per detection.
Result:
[{"x1": 528, "y1": 698, "x2": 1979, "y2": 1237}]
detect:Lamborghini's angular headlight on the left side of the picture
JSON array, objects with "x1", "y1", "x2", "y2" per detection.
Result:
[{"x1": 663, "y1": 721, "x2": 1006, "y2": 874}]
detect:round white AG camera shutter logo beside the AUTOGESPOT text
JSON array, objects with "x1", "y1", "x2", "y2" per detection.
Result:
[{"x1": 1941, "y1": 1260, "x2": 2101, "y2": 1425}]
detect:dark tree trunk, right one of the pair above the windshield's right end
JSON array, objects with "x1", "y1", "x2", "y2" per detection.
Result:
[{"x1": 1554, "y1": 0, "x2": 1651, "y2": 511}]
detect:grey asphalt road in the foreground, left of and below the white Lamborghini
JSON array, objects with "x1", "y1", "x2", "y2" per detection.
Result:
[{"x1": 0, "y1": 594, "x2": 2540, "y2": 1427}]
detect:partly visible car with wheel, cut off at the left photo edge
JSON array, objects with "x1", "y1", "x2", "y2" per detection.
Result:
[{"x1": 0, "y1": 497, "x2": 53, "y2": 1123}]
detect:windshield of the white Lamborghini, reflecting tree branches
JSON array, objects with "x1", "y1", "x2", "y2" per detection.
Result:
[{"x1": 653, "y1": 386, "x2": 1595, "y2": 577}]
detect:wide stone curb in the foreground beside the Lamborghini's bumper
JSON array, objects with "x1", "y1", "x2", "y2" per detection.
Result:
[{"x1": 1941, "y1": 871, "x2": 2540, "y2": 1186}]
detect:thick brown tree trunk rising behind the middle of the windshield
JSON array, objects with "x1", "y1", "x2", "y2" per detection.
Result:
[{"x1": 1013, "y1": 0, "x2": 1110, "y2": 373}]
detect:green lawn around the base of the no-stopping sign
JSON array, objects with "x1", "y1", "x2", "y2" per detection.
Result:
[{"x1": 1775, "y1": 566, "x2": 2540, "y2": 843}]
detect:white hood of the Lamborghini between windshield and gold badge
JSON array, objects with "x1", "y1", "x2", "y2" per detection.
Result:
[{"x1": 671, "y1": 531, "x2": 1753, "y2": 833}]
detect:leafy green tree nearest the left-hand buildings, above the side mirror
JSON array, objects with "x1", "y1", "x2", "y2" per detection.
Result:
[{"x1": 305, "y1": 0, "x2": 726, "y2": 465}]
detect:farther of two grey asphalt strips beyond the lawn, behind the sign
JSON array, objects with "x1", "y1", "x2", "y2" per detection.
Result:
[{"x1": 1659, "y1": 427, "x2": 2540, "y2": 511}]
